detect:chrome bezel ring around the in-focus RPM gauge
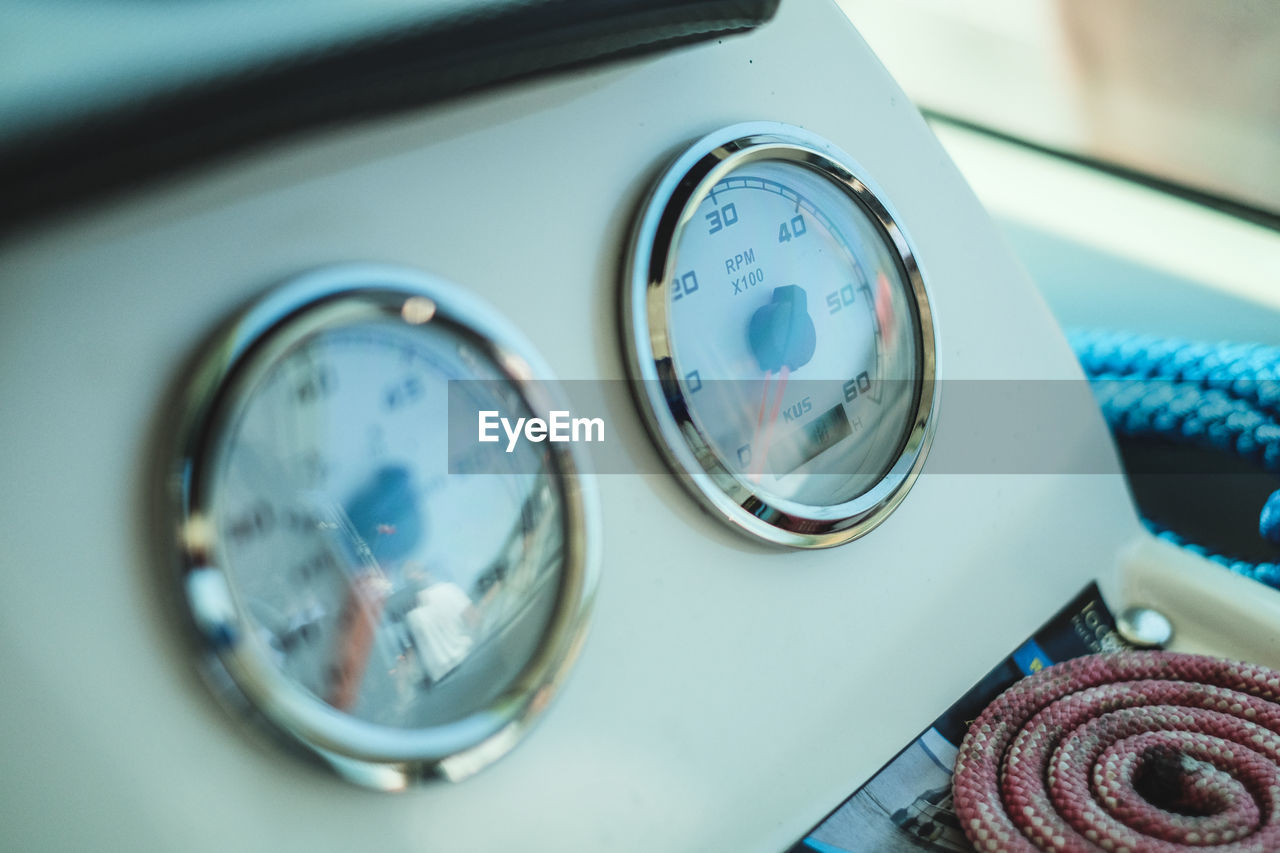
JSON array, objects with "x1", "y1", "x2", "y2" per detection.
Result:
[{"x1": 622, "y1": 122, "x2": 938, "y2": 548}]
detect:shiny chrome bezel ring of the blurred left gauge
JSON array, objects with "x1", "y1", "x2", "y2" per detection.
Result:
[{"x1": 168, "y1": 265, "x2": 598, "y2": 790}]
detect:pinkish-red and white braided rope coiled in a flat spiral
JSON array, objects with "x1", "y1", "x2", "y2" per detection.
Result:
[{"x1": 952, "y1": 652, "x2": 1280, "y2": 853}]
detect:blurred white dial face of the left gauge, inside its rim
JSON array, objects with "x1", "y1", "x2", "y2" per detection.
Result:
[{"x1": 211, "y1": 321, "x2": 563, "y2": 727}]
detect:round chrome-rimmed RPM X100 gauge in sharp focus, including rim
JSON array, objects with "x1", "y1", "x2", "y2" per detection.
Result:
[{"x1": 623, "y1": 123, "x2": 936, "y2": 548}]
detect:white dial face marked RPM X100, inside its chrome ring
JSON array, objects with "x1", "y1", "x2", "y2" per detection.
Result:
[{"x1": 668, "y1": 160, "x2": 919, "y2": 506}]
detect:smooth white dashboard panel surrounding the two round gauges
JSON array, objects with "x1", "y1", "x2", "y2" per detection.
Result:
[{"x1": 0, "y1": 1, "x2": 1139, "y2": 852}]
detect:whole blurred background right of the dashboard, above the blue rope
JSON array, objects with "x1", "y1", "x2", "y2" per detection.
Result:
[{"x1": 838, "y1": 0, "x2": 1280, "y2": 346}]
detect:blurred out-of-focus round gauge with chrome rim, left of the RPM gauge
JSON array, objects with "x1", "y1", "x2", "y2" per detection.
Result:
[{"x1": 173, "y1": 266, "x2": 594, "y2": 789}]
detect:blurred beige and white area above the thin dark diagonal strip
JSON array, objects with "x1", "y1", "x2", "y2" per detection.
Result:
[{"x1": 841, "y1": 0, "x2": 1280, "y2": 216}]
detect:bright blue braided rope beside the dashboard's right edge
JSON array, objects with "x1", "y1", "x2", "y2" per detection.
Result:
[{"x1": 1068, "y1": 330, "x2": 1280, "y2": 589}]
